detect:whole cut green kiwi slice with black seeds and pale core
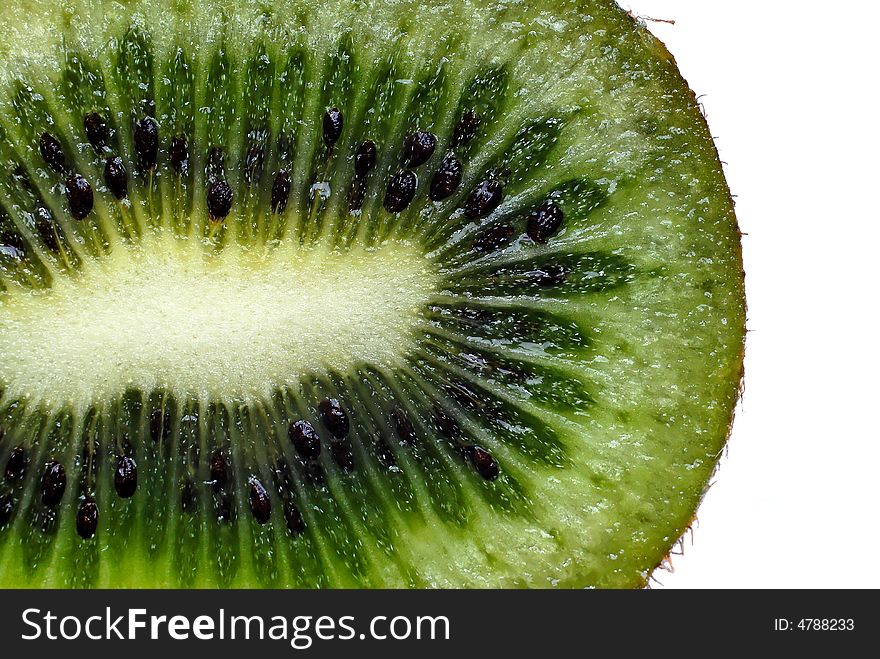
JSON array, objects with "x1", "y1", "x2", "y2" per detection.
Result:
[{"x1": 0, "y1": 0, "x2": 745, "y2": 587}]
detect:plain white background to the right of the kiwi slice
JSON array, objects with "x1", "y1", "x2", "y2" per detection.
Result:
[{"x1": 619, "y1": 0, "x2": 880, "y2": 588}]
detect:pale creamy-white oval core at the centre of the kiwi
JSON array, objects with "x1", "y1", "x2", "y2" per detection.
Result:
[{"x1": 0, "y1": 234, "x2": 437, "y2": 408}]
